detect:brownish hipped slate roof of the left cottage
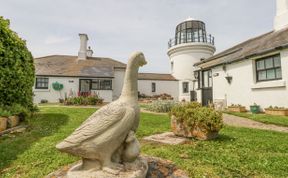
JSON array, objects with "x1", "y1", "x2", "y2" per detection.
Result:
[{"x1": 34, "y1": 55, "x2": 126, "y2": 77}]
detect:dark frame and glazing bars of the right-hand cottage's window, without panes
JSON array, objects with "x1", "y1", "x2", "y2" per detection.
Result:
[{"x1": 255, "y1": 54, "x2": 282, "y2": 82}]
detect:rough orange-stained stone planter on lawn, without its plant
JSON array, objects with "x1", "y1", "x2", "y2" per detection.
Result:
[{"x1": 171, "y1": 116, "x2": 218, "y2": 140}]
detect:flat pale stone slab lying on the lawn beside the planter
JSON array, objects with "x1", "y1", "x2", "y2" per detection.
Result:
[{"x1": 143, "y1": 132, "x2": 189, "y2": 145}]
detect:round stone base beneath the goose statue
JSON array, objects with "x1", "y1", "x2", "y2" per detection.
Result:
[{"x1": 66, "y1": 157, "x2": 148, "y2": 178}]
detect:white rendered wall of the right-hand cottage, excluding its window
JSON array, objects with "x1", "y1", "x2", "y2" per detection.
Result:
[{"x1": 212, "y1": 50, "x2": 288, "y2": 110}]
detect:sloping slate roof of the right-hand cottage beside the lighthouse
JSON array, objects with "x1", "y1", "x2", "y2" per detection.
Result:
[{"x1": 195, "y1": 28, "x2": 288, "y2": 68}]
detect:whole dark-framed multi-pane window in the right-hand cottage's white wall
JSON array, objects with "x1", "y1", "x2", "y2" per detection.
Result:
[{"x1": 256, "y1": 55, "x2": 282, "y2": 82}]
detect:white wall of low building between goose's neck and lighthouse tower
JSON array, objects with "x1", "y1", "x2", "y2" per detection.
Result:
[{"x1": 138, "y1": 80, "x2": 179, "y2": 101}]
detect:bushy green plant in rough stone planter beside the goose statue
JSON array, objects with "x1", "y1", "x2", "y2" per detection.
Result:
[{"x1": 170, "y1": 102, "x2": 223, "y2": 140}]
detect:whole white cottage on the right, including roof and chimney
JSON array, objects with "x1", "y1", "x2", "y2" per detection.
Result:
[{"x1": 194, "y1": 0, "x2": 288, "y2": 109}]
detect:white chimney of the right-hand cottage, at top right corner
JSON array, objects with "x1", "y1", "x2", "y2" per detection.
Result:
[{"x1": 274, "y1": 0, "x2": 288, "y2": 31}]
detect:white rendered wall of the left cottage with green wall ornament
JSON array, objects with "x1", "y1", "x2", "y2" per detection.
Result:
[{"x1": 33, "y1": 77, "x2": 113, "y2": 103}]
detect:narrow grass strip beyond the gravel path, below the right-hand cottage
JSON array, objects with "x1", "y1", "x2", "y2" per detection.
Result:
[{"x1": 225, "y1": 112, "x2": 288, "y2": 127}]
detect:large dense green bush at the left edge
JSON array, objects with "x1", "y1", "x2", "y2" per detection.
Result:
[{"x1": 0, "y1": 17, "x2": 35, "y2": 109}]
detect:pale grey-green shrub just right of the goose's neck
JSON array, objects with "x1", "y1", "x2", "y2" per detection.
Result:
[{"x1": 146, "y1": 100, "x2": 177, "y2": 112}]
